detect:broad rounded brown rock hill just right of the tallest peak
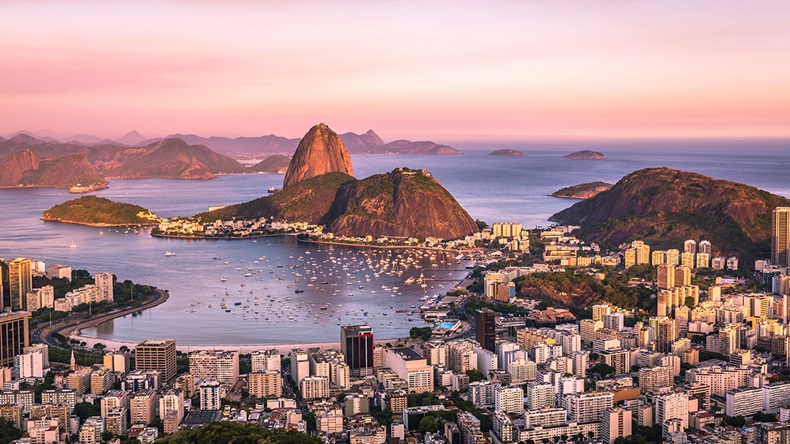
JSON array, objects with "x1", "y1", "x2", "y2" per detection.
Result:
[{"x1": 327, "y1": 168, "x2": 478, "y2": 239}]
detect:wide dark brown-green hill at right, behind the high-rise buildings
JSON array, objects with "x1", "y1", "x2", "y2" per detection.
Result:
[{"x1": 550, "y1": 168, "x2": 790, "y2": 261}]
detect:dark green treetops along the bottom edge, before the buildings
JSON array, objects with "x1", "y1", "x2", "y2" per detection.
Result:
[{"x1": 156, "y1": 421, "x2": 323, "y2": 444}]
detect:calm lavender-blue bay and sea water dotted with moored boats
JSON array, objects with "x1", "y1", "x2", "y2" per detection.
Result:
[{"x1": 0, "y1": 144, "x2": 790, "y2": 344}]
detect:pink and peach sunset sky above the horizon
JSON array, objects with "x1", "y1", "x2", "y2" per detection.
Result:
[{"x1": 0, "y1": 0, "x2": 790, "y2": 142}]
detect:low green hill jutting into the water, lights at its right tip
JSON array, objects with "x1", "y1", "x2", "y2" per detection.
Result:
[{"x1": 41, "y1": 196, "x2": 160, "y2": 227}]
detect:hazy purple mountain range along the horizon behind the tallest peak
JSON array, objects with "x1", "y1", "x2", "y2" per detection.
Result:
[{"x1": 4, "y1": 130, "x2": 463, "y2": 155}]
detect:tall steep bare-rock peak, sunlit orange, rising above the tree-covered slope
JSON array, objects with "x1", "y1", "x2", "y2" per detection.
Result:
[{"x1": 283, "y1": 123, "x2": 354, "y2": 188}]
